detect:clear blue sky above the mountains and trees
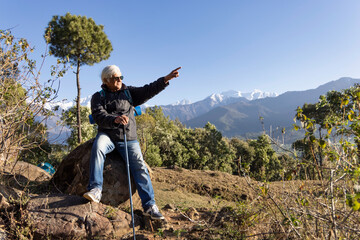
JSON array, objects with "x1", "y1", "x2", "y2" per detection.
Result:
[{"x1": 0, "y1": 0, "x2": 360, "y2": 105}]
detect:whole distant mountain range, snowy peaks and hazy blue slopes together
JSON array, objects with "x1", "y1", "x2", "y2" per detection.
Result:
[{"x1": 47, "y1": 77, "x2": 360, "y2": 142}]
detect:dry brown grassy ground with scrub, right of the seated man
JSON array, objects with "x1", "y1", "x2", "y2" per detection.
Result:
[{"x1": 0, "y1": 162, "x2": 348, "y2": 240}]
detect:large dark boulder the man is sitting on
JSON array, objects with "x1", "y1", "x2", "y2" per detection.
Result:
[{"x1": 52, "y1": 139, "x2": 139, "y2": 206}]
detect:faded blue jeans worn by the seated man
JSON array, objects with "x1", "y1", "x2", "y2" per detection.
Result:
[{"x1": 88, "y1": 132, "x2": 155, "y2": 209}]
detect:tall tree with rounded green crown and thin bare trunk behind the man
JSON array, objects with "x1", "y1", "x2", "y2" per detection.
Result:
[{"x1": 44, "y1": 13, "x2": 113, "y2": 143}]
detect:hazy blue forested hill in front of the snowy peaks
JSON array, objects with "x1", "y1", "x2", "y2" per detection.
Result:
[{"x1": 184, "y1": 78, "x2": 360, "y2": 141}]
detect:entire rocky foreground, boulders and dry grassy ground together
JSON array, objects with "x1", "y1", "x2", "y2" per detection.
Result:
[{"x1": 0, "y1": 140, "x2": 360, "y2": 240}]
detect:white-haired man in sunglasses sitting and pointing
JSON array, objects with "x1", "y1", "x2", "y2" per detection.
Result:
[{"x1": 84, "y1": 65, "x2": 181, "y2": 219}]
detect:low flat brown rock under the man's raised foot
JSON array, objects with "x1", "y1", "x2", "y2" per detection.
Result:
[{"x1": 27, "y1": 194, "x2": 140, "y2": 239}]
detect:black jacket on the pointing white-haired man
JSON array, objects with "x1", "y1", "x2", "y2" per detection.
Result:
[{"x1": 91, "y1": 77, "x2": 169, "y2": 141}]
